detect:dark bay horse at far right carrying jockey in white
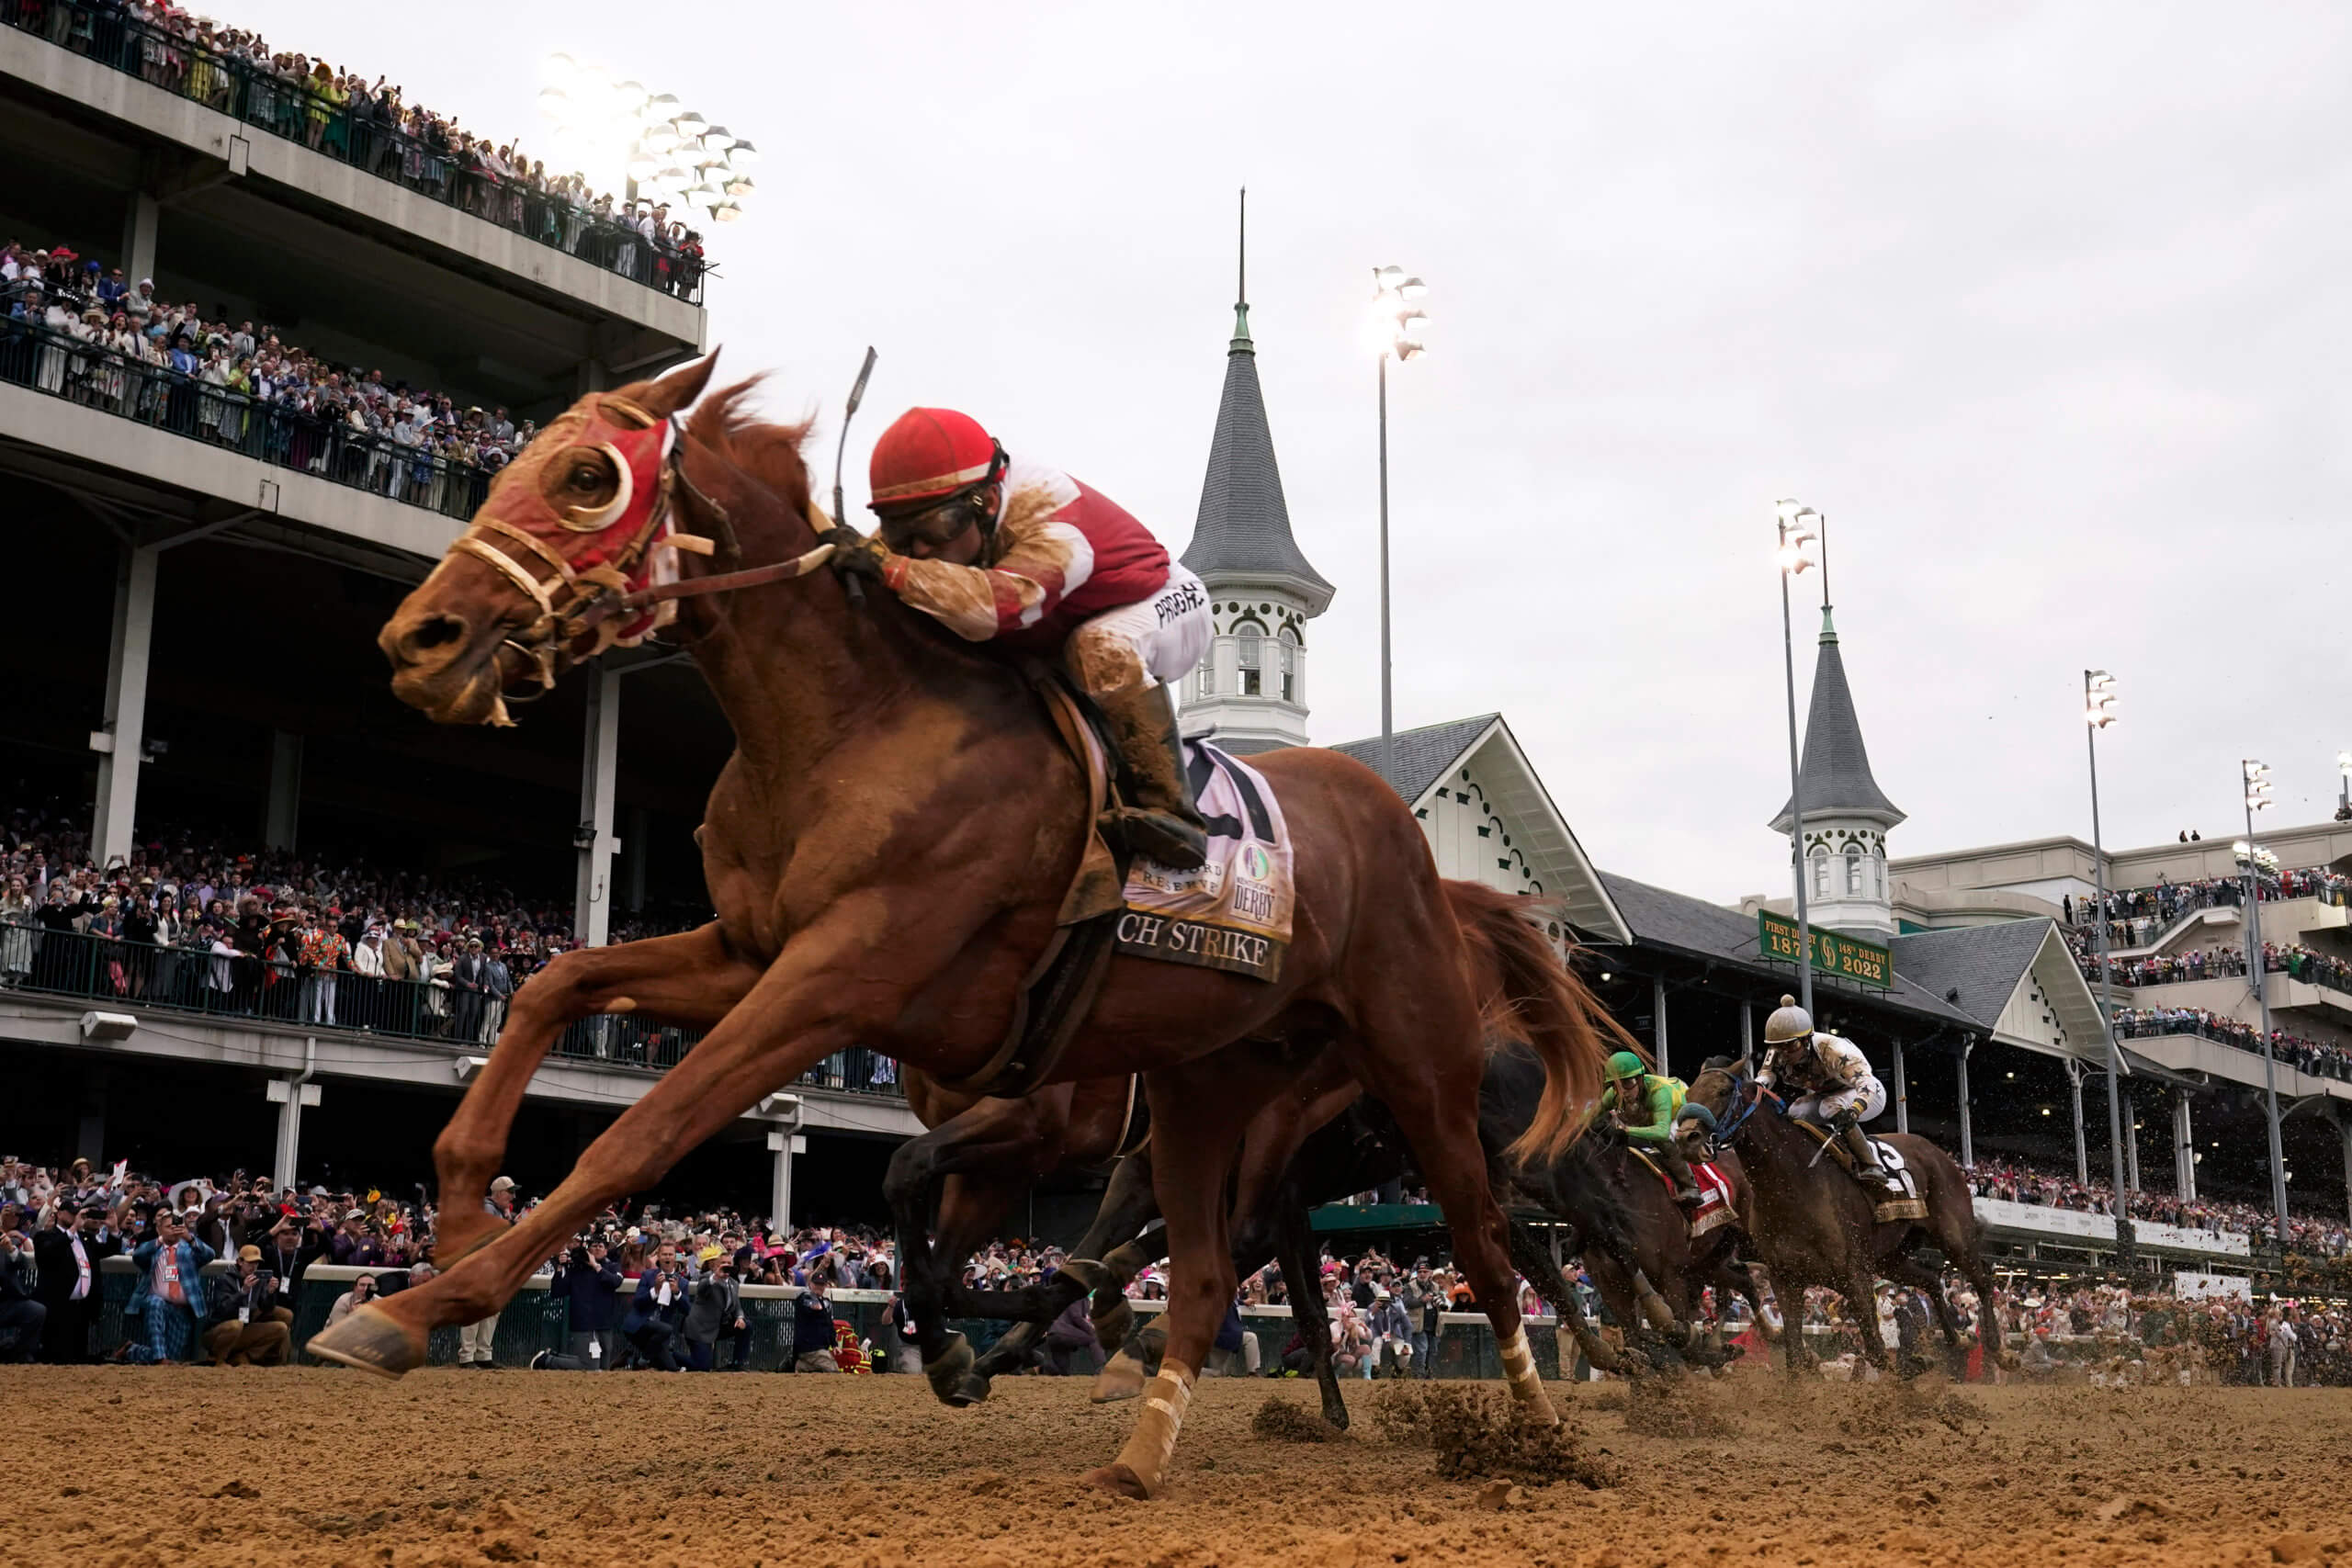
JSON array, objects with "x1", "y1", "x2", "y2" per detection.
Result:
[{"x1": 1691, "y1": 1058, "x2": 2002, "y2": 1371}]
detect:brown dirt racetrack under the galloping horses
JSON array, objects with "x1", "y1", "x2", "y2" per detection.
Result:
[{"x1": 0, "y1": 1366, "x2": 2352, "y2": 1568}]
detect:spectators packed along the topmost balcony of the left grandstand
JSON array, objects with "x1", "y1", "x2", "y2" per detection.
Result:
[{"x1": 0, "y1": 0, "x2": 708, "y2": 299}]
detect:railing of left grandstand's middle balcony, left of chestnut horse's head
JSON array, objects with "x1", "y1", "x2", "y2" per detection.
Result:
[{"x1": 0, "y1": 320, "x2": 492, "y2": 522}]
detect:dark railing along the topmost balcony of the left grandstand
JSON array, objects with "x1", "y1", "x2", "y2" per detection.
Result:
[{"x1": 0, "y1": 0, "x2": 710, "y2": 303}]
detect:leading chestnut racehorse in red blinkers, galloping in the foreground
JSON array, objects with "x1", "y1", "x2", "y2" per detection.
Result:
[{"x1": 311, "y1": 360, "x2": 1601, "y2": 1497}]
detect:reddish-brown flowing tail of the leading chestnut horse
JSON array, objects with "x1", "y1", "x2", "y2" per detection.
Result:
[{"x1": 1444, "y1": 882, "x2": 1634, "y2": 1164}]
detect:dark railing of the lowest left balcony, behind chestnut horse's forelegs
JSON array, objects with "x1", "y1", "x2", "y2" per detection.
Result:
[{"x1": 0, "y1": 924, "x2": 903, "y2": 1098}]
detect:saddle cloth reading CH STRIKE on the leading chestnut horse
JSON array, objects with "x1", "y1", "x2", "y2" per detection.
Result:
[{"x1": 1114, "y1": 740, "x2": 1298, "y2": 980}]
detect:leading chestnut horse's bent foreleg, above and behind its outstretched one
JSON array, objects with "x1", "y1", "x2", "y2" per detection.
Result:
[{"x1": 433, "y1": 921, "x2": 760, "y2": 1272}]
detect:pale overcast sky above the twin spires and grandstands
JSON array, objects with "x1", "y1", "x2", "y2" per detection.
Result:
[{"x1": 221, "y1": 0, "x2": 2352, "y2": 900}]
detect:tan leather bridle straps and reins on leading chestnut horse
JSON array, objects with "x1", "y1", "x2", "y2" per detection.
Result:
[{"x1": 452, "y1": 411, "x2": 835, "y2": 703}]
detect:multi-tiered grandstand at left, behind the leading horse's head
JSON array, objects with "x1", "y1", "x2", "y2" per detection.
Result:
[{"x1": 0, "y1": 5, "x2": 915, "y2": 1213}]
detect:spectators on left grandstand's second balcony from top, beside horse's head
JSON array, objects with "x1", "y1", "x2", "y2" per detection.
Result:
[{"x1": 0, "y1": 240, "x2": 538, "y2": 514}]
